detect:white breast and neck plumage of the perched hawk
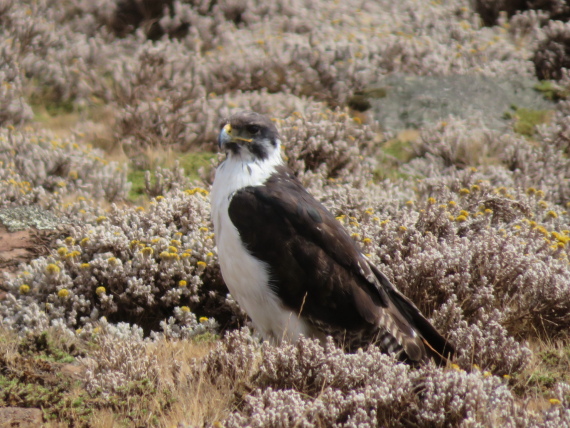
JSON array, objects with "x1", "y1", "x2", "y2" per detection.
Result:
[{"x1": 211, "y1": 151, "x2": 310, "y2": 342}]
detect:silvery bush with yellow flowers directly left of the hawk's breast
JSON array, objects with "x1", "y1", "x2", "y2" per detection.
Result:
[{"x1": 0, "y1": 188, "x2": 225, "y2": 337}]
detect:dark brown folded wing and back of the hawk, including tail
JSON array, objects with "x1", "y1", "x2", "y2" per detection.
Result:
[{"x1": 229, "y1": 168, "x2": 447, "y2": 361}]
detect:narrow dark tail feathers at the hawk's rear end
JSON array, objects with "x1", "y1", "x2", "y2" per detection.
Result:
[{"x1": 369, "y1": 263, "x2": 455, "y2": 365}]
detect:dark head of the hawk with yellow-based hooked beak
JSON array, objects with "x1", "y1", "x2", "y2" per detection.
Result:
[{"x1": 218, "y1": 111, "x2": 281, "y2": 160}]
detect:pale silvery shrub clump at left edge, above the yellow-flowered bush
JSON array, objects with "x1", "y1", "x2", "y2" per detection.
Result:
[{"x1": 0, "y1": 129, "x2": 130, "y2": 208}]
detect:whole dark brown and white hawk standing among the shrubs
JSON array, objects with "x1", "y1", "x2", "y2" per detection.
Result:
[{"x1": 211, "y1": 111, "x2": 453, "y2": 363}]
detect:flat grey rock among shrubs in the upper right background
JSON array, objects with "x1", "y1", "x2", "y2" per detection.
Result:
[{"x1": 355, "y1": 74, "x2": 554, "y2": 131}]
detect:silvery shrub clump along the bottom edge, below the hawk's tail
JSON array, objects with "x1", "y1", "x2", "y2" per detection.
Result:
[{"x1": 201, "y1": 332, "x2": 556, "y2": 427}]
